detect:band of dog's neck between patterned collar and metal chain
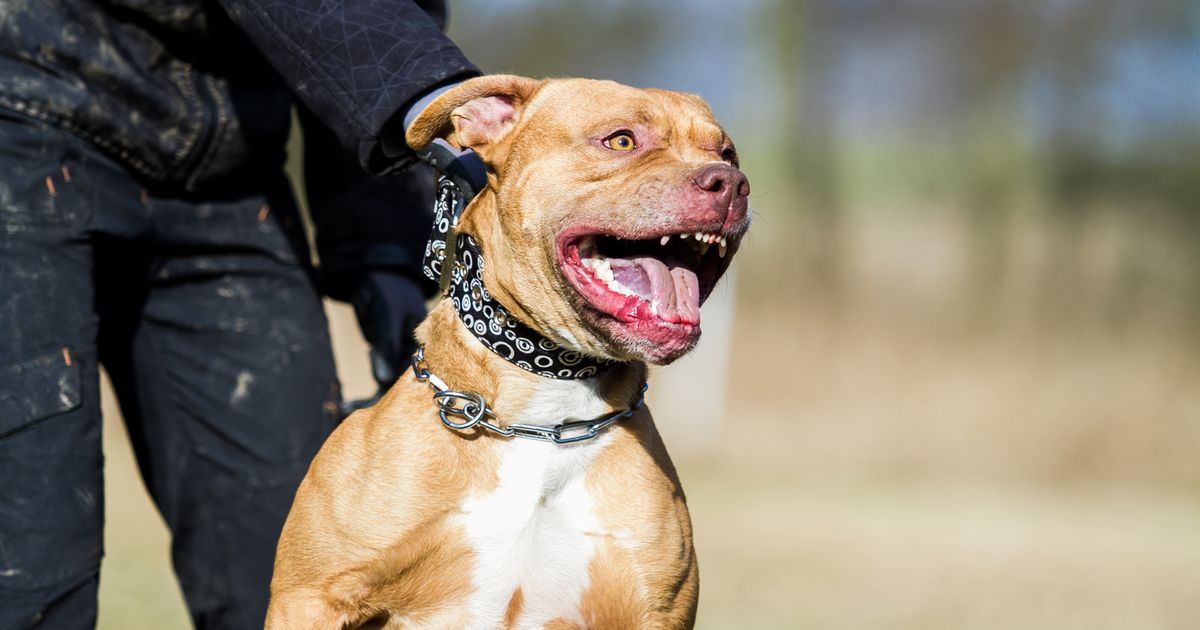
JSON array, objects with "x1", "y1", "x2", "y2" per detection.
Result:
[{"x1": 416, "y1": 299, "x2": 647, "y2": 426}]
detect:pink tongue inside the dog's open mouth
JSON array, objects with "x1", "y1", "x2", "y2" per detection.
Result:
[{"x1": 608, "y1": 257, "x2": 700, "y2": 324}]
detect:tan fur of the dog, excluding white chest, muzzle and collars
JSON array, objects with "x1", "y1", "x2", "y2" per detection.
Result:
[{"x1": 266, "y1": 76, "x2": 744, "y2": 630}]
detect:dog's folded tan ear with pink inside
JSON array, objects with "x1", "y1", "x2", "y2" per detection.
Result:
[{"x1": 407, "y1": 74, "x2": 541, "y2": 163}]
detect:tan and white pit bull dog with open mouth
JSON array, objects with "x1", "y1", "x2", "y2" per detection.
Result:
[{"x1": 266, "y1": 76, "x2": 750, "y2": 630}]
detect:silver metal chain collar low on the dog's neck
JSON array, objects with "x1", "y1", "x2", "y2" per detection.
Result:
[{"x1": 413, "y1": 346, "x2": 649, "y2": 444}]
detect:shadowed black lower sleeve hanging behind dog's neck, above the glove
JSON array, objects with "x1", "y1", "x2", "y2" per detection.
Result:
[{"x1": 300, "y1": 108, "x2": 437, "y2": 300}]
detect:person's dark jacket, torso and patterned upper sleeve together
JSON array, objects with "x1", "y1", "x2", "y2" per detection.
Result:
[{"x1": 0, "y1": 0, "x2": 478, "y2": 192}]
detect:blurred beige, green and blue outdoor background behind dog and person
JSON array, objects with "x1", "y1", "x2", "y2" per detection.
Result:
[{"x1": 101, "y1": 0, "x2": 1200, "y2": 630}]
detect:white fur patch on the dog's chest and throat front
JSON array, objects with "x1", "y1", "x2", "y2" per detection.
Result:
[{"x1": 458, "y1": 382, "x2": 611, "y2": 629}]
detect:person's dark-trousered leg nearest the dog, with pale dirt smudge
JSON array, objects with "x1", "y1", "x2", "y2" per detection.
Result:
[{"x1": 104, "y1": 178, "x2": 338, "y2": 629}]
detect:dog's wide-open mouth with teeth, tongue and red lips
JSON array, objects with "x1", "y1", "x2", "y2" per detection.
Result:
[{"x1": 560, "y1": 230, "x2": 738, "y2": 331}]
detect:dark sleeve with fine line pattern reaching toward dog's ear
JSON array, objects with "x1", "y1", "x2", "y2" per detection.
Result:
[{"x1": 220, "y1": 0, "x2": 479, "y2": 174}]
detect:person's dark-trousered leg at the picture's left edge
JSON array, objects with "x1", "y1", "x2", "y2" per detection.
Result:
[{"x1": 0, "y1": 114, "x2": 104, "y2": 630}]
